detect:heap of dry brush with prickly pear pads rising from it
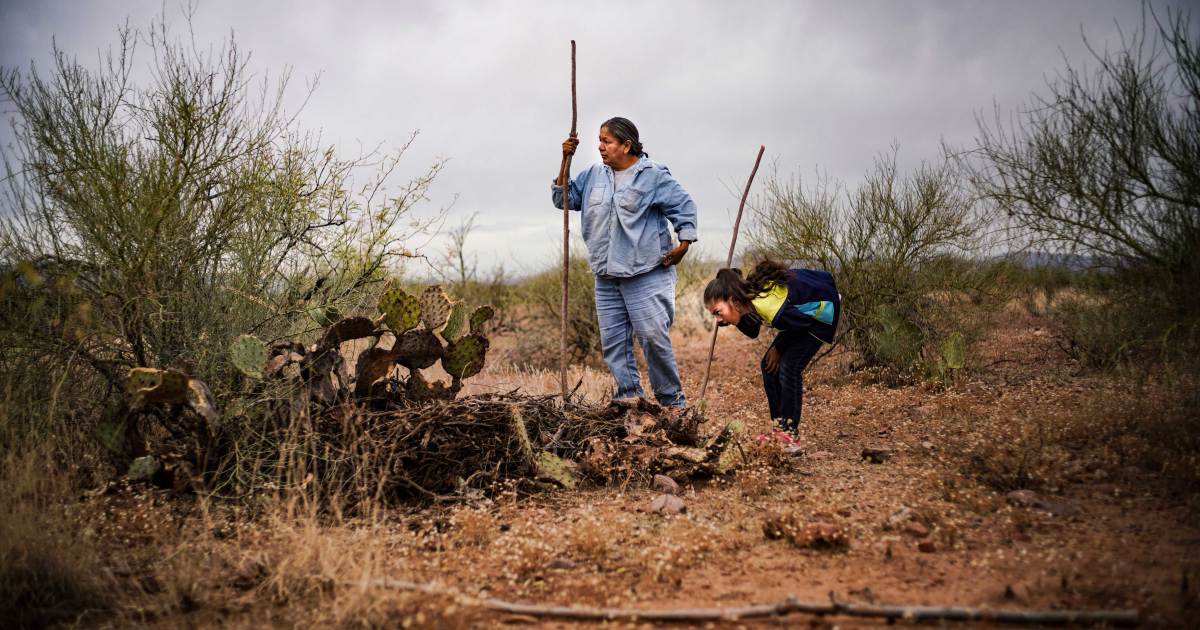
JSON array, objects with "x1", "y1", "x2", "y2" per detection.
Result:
[{"x1": 114, "y1": 286, "x2": 737, "y2": 505}]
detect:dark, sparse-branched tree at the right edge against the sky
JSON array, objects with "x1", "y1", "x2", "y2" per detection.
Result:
[{"x1": 964, "y1": 8, "x2": 1200, "y2": 317}]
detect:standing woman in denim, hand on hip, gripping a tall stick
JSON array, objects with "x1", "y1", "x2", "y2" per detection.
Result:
[{"x1": 552, "y1": 118, "x2": 696, "y2": 407}]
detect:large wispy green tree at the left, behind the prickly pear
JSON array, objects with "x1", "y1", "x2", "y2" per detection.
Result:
[{"x1": 0, "y1": 15, "x2": 440, "y2": 446}]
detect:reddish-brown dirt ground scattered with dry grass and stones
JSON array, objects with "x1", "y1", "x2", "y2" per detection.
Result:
[{"x1": 68, "y1": 316, "x2": 1200, "y2": 628}]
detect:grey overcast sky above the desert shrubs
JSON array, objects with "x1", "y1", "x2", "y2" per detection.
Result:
[{"x1": 0, "y1": 0, "x2": 1187, "y2": 274}]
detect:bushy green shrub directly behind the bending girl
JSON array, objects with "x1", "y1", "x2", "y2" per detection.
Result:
[{"x1": 746, "y1": 150, "x2": 1002, "y2": 376}]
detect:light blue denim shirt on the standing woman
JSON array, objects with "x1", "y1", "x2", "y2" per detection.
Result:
[{"x1": 551, "y1": 157, "x2": 696, "y2": 277}]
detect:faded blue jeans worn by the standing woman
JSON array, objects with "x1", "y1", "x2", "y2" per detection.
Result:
[{"x1": 596, "y1": 266, "x2": 688, "y2": 407}]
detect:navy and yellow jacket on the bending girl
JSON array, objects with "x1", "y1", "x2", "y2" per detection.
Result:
[{"x1": 738, "y1": 269, "x2": 841, "y2": 352}]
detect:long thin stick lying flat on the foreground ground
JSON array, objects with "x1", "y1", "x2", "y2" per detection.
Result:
[{"x1": 362, "y1": 580, "x2": 1139, "y2": 626}]
